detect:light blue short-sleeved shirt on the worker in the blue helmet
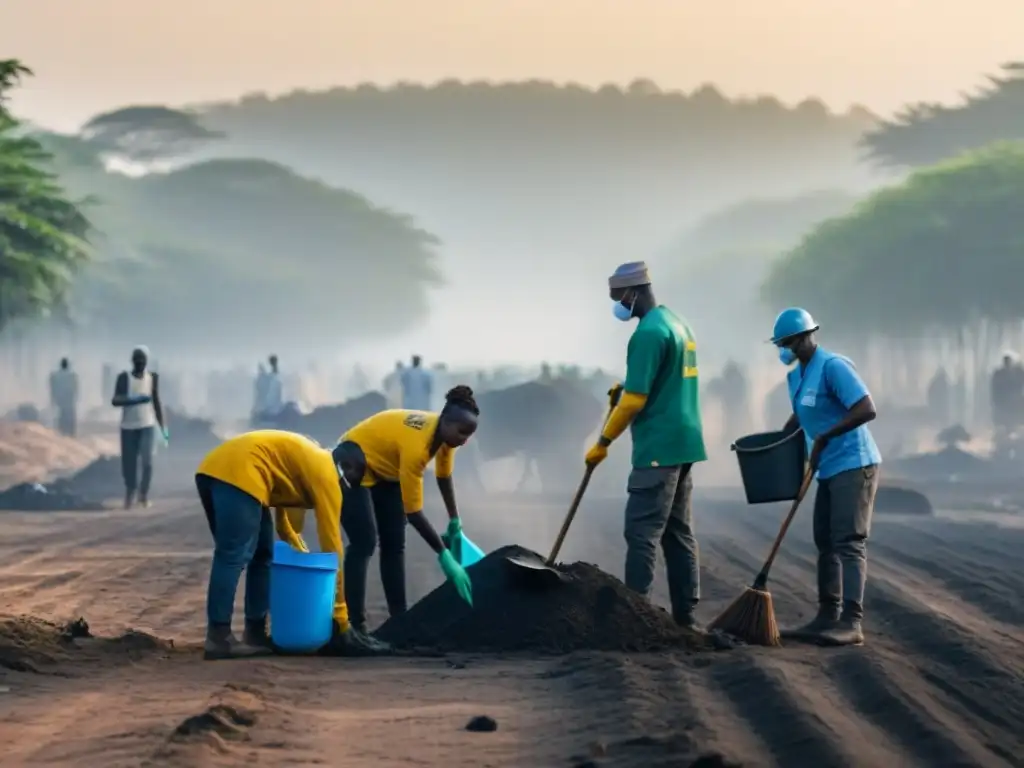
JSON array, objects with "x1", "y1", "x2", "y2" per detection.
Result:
[{"x1": 786, "y1": 347, "x2": 882, "y2": 480}]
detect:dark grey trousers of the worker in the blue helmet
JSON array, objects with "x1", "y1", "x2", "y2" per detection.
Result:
[{"x1": 814, "y1": 465, "x2": 879, "y2": 618}]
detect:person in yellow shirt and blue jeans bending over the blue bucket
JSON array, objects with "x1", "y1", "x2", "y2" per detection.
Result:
[{"x1": 196, "y1": 429, "x2": 390, "y2": 659}]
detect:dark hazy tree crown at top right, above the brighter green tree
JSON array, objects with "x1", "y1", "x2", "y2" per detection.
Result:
[{"x1": 861, "y1": 62, "x2": 1024, "y2": 167}]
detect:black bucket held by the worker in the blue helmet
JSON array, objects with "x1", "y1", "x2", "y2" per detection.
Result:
[{"x1": 732, "y1": 429, "x2": 807, "y2": 504}]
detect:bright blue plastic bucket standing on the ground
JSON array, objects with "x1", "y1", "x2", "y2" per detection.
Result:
[{"x1": 270, "y1": 542, "x2": 338, "y2": 653}]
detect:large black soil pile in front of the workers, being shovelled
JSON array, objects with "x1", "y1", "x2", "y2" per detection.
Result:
[{"x1": 375, "y1": 545, "x2": 713, "y2": 653}]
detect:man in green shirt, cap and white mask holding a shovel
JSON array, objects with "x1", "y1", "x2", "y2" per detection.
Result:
[{"x1": 586, "y1": 261, "x2": 708, "y2": 631}]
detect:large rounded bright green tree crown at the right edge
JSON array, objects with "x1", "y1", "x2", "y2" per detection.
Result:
[{"x1": 764, "y1": 143, "x2": 1024, "y2": 337}]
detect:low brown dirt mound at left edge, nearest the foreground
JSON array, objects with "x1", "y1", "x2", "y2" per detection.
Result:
[{"x1": 0, "y1": 616, "x2": 174, "y2": 674}]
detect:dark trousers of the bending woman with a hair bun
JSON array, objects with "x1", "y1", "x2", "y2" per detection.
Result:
[{"x1": 341, "y1": 480, "x2": 409, "y2": 628}]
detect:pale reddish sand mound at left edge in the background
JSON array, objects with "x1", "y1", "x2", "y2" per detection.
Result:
[{"x1": 0, "y1": 421, "x2": 99, "y2": 488}]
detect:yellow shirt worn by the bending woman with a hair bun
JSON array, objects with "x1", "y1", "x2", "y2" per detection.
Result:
[{"x1": 341, "y1": 410, "x2": 455, "y2": 514}]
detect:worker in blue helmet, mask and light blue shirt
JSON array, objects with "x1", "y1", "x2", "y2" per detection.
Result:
[{"x1": 771, "y1": 307, "x2": 882, "y2": 645}]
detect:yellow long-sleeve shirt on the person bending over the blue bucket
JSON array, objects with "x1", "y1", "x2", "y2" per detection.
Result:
[{"x1": 196, "y1": 429, "x2": 348, "y2": 630}]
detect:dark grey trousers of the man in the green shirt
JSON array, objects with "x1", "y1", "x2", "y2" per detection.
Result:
[{"x1": 626, "y1": 464, "x2": 700, "y2": 622}]
